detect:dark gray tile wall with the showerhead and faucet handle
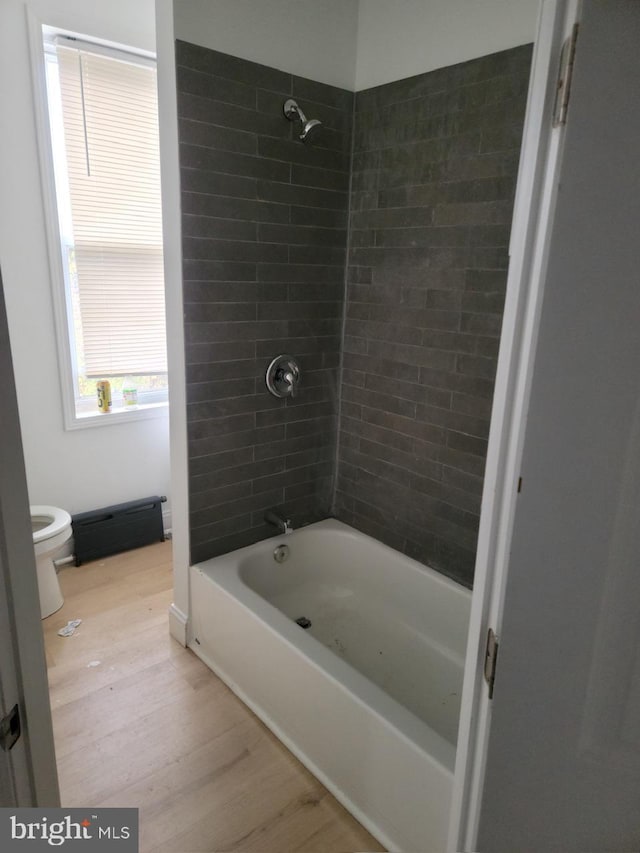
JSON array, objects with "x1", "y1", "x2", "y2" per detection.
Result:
[{"x1": 176, "y1": 42, "x2": 353, "y2": 562}]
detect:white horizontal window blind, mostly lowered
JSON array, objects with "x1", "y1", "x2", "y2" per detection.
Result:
[{"x1": 56, "y1": 44, "x2": 167, "y2": 377}]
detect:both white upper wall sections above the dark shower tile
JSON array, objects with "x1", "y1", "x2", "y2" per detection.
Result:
[{"x1": 173, "y1": 0, "x2": 539, "y2": 90}]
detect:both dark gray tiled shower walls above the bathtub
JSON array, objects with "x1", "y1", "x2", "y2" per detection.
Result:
[{"x1": 177, "y1": 42, "x2": 531, "y2": 585}]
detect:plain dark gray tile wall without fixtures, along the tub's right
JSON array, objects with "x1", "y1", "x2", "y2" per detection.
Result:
[{"x1": 335, "y1": 46, "x2": 531, "y2": 586}]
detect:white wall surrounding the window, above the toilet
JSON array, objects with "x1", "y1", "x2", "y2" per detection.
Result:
[{"x1": 0, "y1": 0, "x2": 170, "y2": 513}]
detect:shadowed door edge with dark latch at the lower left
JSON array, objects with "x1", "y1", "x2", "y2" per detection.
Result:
[{"x1": 0, "y1": 272, "x2": 60, "y2": 807}]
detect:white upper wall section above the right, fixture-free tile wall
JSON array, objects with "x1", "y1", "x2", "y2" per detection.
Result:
[{"x1": 355, "y1": 0, "x2": 539, "y2": 91}]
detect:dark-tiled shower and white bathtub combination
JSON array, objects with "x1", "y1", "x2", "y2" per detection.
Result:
[{"x1": 177, "y1": 42, "x2": 531, "y2": 850}]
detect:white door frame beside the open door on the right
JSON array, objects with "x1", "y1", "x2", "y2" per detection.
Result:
[{"x1": 448, "y1": 0, "x2": 581, "y2": 851}]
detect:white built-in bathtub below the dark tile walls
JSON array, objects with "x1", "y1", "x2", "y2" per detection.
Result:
[{"x1": 190, "y1": 520, "x2": 471, "y2": 853}]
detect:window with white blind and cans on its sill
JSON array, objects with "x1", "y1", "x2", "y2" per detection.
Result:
[{"x1": 45, "y1": 36, "x2": 167, "y2": 426}]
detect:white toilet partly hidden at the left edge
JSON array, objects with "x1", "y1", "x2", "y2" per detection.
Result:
[{"x1": 31, "y1": 506, "x2": 71, "y2": 619}]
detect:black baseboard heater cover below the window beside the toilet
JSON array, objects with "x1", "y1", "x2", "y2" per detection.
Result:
[{"x1": 71, "y1": 495, "x2": 166, "y2": 566}]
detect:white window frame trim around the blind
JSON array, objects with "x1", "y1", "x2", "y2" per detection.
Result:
[{"x1": 27, "y1": 14, "x2": 169, "y2": 430}]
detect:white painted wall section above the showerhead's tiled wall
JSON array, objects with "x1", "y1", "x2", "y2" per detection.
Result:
[{"x1": 173, "y1": 0, "x2": 360, "y2": 89}]
